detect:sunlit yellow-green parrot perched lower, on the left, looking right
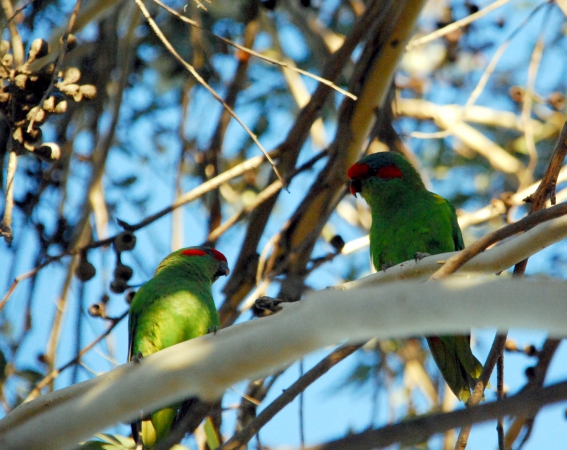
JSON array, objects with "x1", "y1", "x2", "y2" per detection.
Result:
[{"x1": 128, "y1": 247, "x2": 230, "y2": 449}]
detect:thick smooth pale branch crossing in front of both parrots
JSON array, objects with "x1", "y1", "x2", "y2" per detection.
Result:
[{"x1": 0, "y1": 278, "x2": 567, "y2": 450}]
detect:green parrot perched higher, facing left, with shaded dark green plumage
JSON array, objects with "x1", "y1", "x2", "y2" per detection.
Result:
[{"x1": 347, "y1": 152, "x2": 482, "y2": 402}]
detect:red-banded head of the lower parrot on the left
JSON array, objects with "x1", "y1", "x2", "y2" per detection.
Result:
[{"x1": 156, "y1": 247, "x2": 230, "y2": 283}]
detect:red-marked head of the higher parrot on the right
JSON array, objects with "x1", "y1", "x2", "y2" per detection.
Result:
[{"x1": 347, "y1": 152, "x2": 423, "y2": 197}]
